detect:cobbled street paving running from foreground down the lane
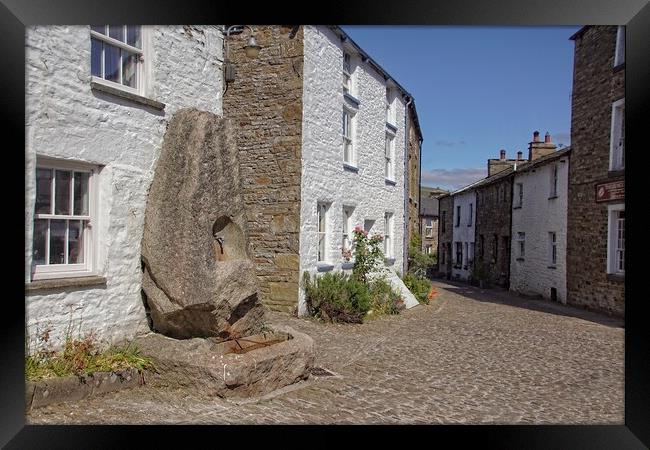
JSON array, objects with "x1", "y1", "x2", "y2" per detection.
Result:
[{"x1": 26, "y1": 281, "x2": 624, "y2": 424}]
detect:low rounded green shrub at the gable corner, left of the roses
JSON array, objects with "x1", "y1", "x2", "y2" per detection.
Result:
[{"x1": 303, "y1": 272, "x2": 370, "y2": 323}]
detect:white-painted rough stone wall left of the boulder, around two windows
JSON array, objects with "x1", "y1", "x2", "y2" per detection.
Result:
[{"x1": 25, "y1": 26, "x2": 223, "y2": 347}]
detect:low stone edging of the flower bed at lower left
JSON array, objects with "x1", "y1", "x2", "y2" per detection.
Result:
[{"x1": 25, "y1": 369, "x2": 144, "y2": 411}]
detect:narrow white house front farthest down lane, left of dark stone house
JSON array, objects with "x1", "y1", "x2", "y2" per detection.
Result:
[{"x1": 451, "y1": 191, "x2": 476, "y2": 280}]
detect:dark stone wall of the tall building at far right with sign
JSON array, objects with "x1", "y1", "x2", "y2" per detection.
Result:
[{"x1": 567, "y1": 26, "x2": 625, "y2": 316}]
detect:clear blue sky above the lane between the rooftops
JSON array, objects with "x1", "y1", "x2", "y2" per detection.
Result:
[{"x1": 341, "y1": 26, "x2": 580, "y2": 189}]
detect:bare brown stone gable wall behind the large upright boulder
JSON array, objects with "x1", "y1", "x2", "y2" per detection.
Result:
[{"x1": 223, "y1": 26, "x2": 304, "y2": 311}]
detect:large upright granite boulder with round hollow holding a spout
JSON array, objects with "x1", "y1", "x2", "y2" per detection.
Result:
[{"x1": 142, "y1": 109, "x2": 264, "y2": 341}]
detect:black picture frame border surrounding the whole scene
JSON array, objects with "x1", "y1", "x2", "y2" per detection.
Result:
[{"x1": 0, "y1": 0, "x2": 650, "y2": 449}]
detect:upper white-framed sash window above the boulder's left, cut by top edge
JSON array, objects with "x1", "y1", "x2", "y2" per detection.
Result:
[{"x1": 90, "y1": 25, "x2": 144, "y2": 93}]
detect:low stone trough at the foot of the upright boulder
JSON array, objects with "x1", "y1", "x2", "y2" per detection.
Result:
[{"x1": 136, "y1": 325, "x2": 314, "y2": 397}]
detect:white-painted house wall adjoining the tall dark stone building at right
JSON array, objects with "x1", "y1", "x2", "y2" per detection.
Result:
[{"x1": 510, "y1": 155, "x2": 569, "y2": 303}]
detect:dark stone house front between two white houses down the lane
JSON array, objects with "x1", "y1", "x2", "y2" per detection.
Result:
[{"x1": 475, "y1": 175, "x2": 514, "y2": 287}]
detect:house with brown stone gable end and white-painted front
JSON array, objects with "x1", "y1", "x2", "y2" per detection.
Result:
[{"x1": 223, "y1": 25, "x2": 422, "y2": 314}]
